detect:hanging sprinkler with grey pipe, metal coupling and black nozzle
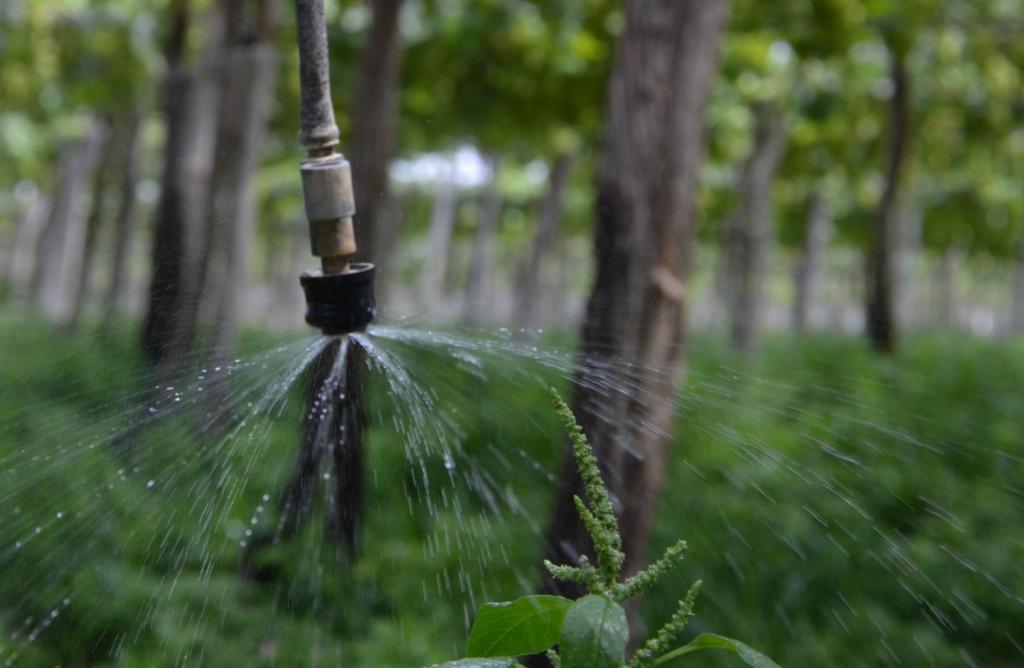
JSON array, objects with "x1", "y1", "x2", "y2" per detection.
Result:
[{"x1": 295, "y1": 0, "x2": 377, "y2": 335}]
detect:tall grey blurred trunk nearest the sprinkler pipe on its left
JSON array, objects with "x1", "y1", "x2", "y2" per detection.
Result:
[{"x1": 199, "y1": 0, "x2": 278, "y2": 358}]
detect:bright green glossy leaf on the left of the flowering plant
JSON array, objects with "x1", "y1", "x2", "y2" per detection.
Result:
[{"x1": 467, "y1": 596, "x2": 572, "y2": 657}]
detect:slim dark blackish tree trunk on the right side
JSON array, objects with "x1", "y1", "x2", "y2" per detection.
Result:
[{"x1": 865, "y1": 49, "x2": 910, "y2": 352}]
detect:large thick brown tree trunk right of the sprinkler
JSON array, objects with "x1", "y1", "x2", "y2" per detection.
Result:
[{"x1": 546, "y1": 0, "x2": 729, "y2": 618}]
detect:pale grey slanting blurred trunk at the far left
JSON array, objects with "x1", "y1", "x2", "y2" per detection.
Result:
[{"x1": 30, "y1": 119, "x2": 110, "y2": 323}]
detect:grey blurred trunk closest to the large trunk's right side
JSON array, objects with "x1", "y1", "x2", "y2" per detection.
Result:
[{"x1": 728, "y1": 105, "x2": 785, "y2": 356}]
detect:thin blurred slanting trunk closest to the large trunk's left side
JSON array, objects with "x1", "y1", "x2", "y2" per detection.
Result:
[{"x1": 514, "y1": 153, "x2": 574, "y2": 330}]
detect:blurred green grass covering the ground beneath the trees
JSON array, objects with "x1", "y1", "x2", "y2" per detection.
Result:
[{"x1": 0, "y1": 316, "x2": 1024, "y2": 666}]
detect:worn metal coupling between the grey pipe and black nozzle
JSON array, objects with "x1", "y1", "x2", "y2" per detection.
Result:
[{"x1": 299, "y1": 153, "x2": 355, "y2": 258}]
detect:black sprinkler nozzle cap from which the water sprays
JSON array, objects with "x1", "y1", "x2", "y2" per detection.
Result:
[{"x1": 299, "y1": 262, "x2": 377, "y2": 335}]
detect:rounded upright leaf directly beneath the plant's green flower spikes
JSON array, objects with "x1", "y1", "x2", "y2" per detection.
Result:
[{"x1": 559, "y1": 595, "x2": 630, "y2": 668}]
